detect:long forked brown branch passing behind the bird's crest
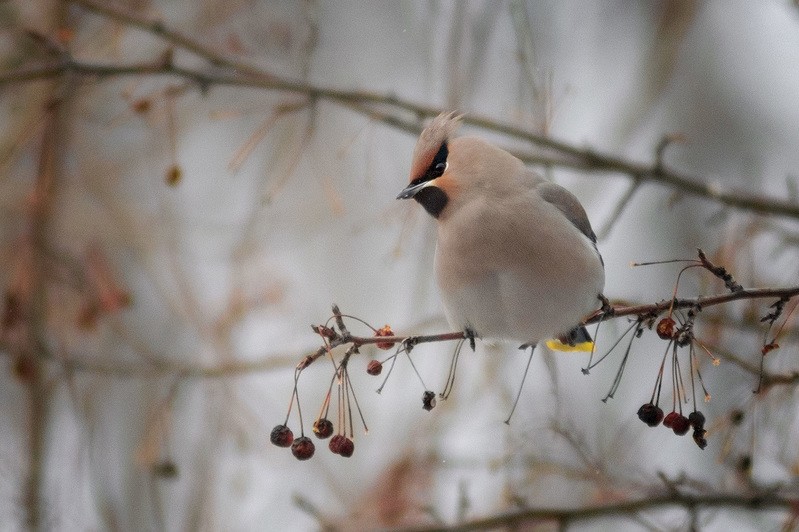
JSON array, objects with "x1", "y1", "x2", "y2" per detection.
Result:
[{"x1": 0, "y1": 0, "x2": 799, "y2": 219}]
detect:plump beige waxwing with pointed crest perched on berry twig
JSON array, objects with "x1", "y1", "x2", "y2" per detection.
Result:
[{"x1": 397, "y1": 113, "x2": 605, "y2": 350}]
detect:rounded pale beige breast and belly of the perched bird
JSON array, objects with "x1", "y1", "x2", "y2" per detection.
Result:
[{"x1": 436, "y1": 197, "x2": 604, "y2": 343}]
